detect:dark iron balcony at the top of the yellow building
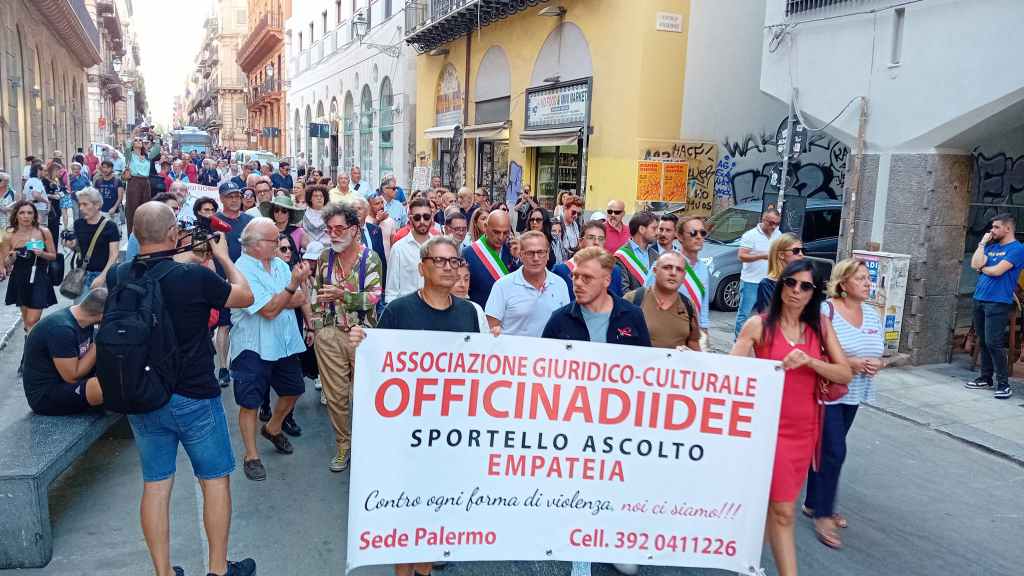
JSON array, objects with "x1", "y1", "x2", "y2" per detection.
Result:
[{"x1": 406, "y1": 0, "x2": 544, "y2": 52}]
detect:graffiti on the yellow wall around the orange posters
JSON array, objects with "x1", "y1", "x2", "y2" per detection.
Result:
[{"x1": 638, "y1": 140, "x2": 718, "y2": 216}]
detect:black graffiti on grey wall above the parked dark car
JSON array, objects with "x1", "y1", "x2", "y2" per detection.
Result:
[{"x1": 714, "y1": 118, "x2": 850, "y2": 204}]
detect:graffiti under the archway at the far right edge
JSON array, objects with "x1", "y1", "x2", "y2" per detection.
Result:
[{"x1": 967, "y1": 147, "x2": 1024, "y2": 238}]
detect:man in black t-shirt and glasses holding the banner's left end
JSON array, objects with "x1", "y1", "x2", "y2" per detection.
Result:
[{"x1": 348, "y1": 236, "x2": 480, "y2": 574}]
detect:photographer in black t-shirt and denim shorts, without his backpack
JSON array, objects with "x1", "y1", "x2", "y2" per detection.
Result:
[{"x1": 116, "y1": 202, "x2": 256, "y2": 576}]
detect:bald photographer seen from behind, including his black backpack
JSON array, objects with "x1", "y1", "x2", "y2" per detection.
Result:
[{"x1": 96, "y1": 201, "x2": 256, "y2": 576}]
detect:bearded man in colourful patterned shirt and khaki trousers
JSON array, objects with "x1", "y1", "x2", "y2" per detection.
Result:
[{"x1": 312, "y1": 202, "x2": 382, "y2": 472}]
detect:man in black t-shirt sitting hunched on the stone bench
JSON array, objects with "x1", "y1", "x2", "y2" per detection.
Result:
[{"x1": 22, "y1": 288, "x2": 106, "y2": 416}]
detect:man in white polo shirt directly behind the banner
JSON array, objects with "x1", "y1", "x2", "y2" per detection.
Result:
[{"x1": 483, "y1": 231, "x2": 569, "y2": 337}]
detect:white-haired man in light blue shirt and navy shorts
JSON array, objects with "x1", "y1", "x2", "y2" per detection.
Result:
[{"x1": 230, "y1": 216, "x2": 309, "y2": 481}]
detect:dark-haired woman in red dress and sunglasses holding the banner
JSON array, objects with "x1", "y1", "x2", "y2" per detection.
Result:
[{"x1": 732, "y1": 260, "x2": 853, "y2": 576}]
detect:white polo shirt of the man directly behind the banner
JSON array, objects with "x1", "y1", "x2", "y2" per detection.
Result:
[{"x1": 483, "y1": 268, "x2": 569, "y2": 338}]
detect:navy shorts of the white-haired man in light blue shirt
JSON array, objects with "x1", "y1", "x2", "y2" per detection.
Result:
[{"x1": 231, "y1": 349, "x2": 306, "y2": 410}]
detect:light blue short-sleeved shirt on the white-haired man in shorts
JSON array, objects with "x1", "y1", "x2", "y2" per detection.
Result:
[{"x1": 229, "y1": 253, "x2": 306, "y2": 362}]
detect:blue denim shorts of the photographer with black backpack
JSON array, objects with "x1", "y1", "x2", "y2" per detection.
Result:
[{"x1": 128, "y1": 394, "x2": 234, "y2": 482}]
